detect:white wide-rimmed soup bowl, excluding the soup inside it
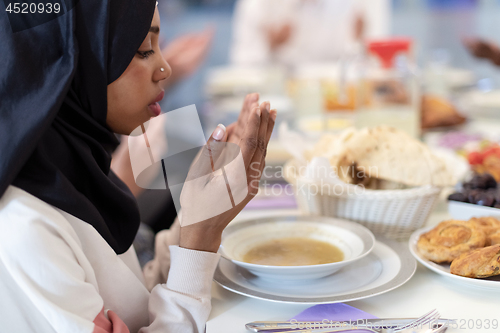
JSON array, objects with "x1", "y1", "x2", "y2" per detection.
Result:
[{"x1": 219, "y1": 216, "x2": 375, "y2": 281}]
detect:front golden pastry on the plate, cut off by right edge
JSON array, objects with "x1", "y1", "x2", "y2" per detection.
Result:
[{"x1": 450, "y1": 244, "x2": 500, "y2": 278}]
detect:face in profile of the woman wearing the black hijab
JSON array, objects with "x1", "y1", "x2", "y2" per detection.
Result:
[{"x1": 106, "y1": 8, "x2": 172, "y2": 135}]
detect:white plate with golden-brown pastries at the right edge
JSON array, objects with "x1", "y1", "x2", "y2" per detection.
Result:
[{"x1": 409, "y1": 217, "x2": 500, "y2": 291}]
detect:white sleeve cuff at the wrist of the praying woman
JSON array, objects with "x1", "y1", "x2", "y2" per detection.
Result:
[{"x1": 167, "y1": 245, "x2": 220, "y2": 299}]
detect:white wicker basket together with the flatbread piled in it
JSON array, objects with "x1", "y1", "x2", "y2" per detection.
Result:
[{"x1": 283, "y1": 126, "x2": 460, "y2": 238}]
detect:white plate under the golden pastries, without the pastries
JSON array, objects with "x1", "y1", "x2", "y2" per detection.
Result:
[{"x1": 409, "y1": 227, "x2": 500, "y2": 291}]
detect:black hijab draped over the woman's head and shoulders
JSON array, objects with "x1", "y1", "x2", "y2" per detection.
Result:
[{"x1": 0, "y1": 0, "x2": 156, "y2": 254}]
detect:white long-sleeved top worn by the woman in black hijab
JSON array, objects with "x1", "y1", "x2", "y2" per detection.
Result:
[{"x1": 0, "y1": 186, "x2": 219, "y2": 333}]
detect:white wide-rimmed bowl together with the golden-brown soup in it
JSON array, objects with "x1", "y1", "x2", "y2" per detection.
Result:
[{"x1": 219, "y1": 216, "x2": 375, "y2": 280}]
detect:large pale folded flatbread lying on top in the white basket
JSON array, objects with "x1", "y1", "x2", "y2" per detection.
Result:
[{"x1": 314, "y1": 126, "x2": 455, "y2": 187}]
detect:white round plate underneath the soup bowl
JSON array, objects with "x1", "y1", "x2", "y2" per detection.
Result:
[{"x1": 214, "y1": 231, "x2": 417, "y2": 304}]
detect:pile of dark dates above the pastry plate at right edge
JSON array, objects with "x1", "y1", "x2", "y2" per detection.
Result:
[{"x1": 448, "y1": 173, "x2": 500, "y2": 208}]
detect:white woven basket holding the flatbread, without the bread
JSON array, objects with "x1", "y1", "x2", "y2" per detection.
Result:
[{"x1": 284, "y1": 160, "x2": 441, "y2": 238}]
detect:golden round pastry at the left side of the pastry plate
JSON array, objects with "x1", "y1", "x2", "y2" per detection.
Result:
[{"x1": 417, "y1": 220, "x2": 486, "y2": 264}]
